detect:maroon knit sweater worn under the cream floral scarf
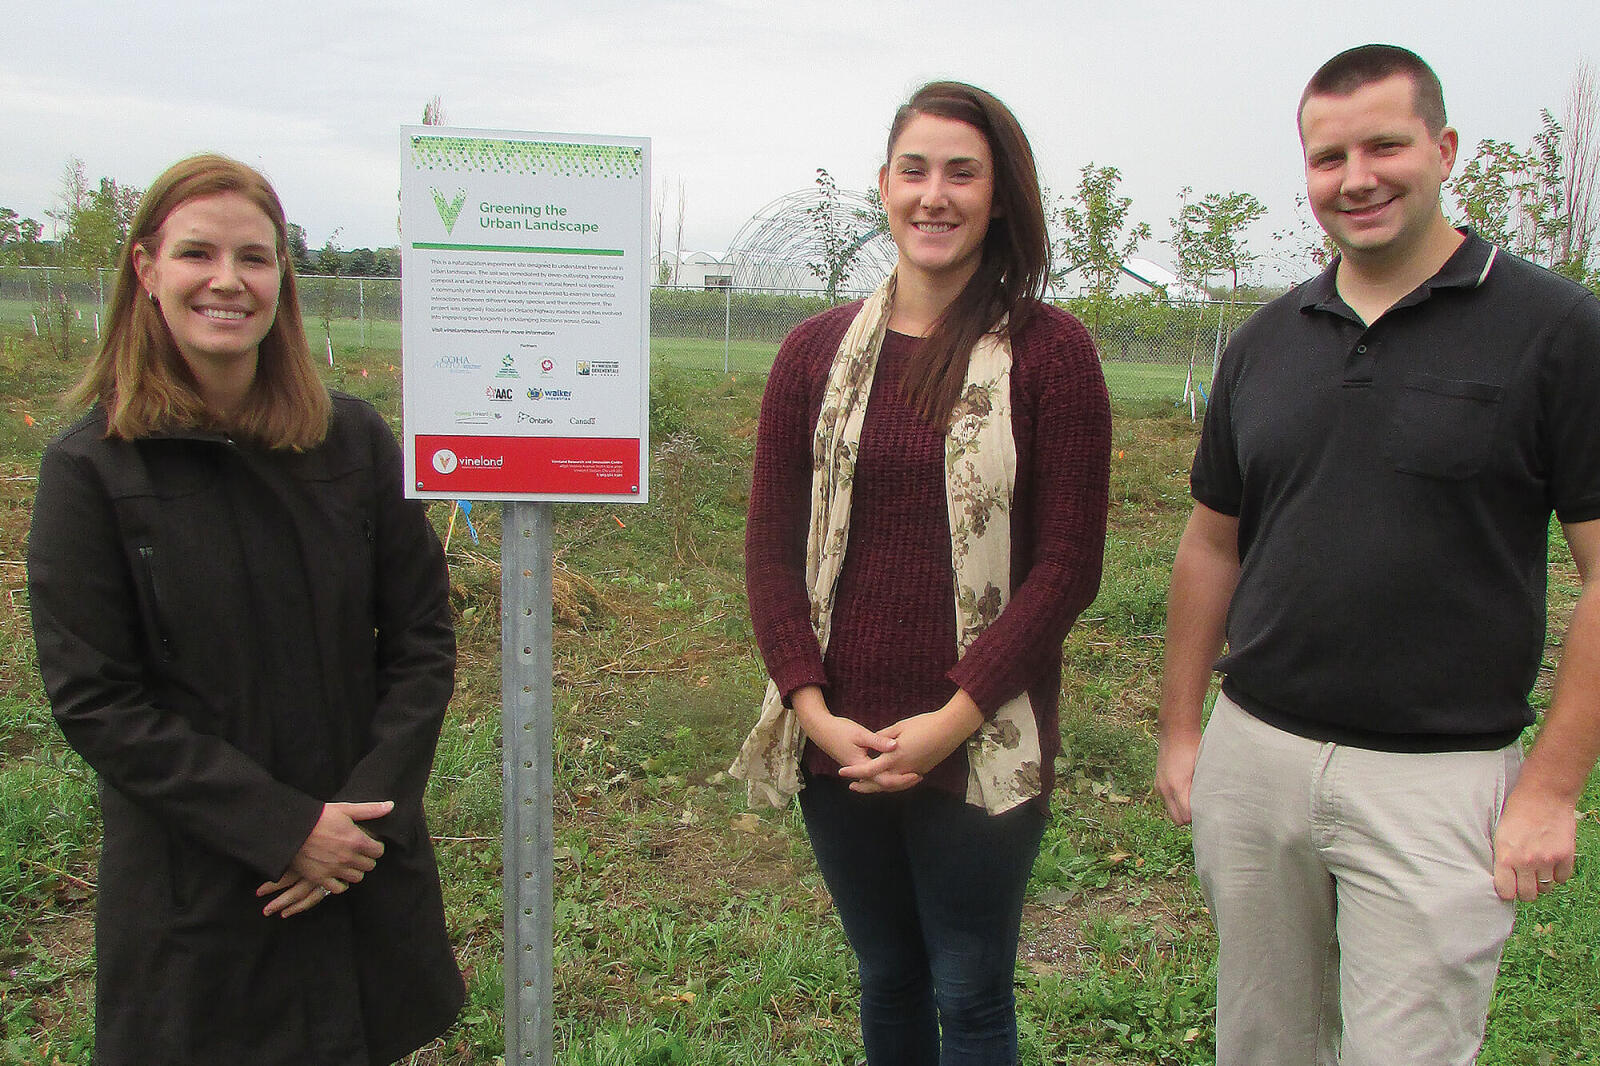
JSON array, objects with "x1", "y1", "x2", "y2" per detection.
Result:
[{"x1": 744, "y1": 303, "x2": 1110, "y2": 807}]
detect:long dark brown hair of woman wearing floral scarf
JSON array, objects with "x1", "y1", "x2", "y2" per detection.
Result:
[{"x1": 885, "y1": 82, "x2": 1050, "y2": 426}]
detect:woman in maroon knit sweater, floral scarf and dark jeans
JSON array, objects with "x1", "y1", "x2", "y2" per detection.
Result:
[{"x1": 734, "y1": 82, "x2": 1110, "y2": 1066}]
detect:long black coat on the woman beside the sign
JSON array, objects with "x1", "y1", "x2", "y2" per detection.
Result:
[{"x1": 29, "y1": 395, "x2": 462, "y2": 1066}]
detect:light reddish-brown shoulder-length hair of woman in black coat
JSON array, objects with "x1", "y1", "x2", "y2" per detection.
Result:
[{"x1": 67, "y1": 155, "x2": 333, "y2": 448}]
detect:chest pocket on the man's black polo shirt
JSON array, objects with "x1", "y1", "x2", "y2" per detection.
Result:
[{"x1": 1386, "y1": 373, "x2": 1501, "y2": 480}]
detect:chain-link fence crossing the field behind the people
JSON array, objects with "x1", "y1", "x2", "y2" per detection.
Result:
[{"x1": 0, "y1": 267, "x2": 1256, "y2": 408}]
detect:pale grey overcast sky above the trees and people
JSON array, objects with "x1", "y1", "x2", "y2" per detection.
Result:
[{"x1": 0, "y1": 0, "x2": 1600, "y2": 279}]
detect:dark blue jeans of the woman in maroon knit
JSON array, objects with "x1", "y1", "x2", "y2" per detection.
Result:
[{"x1": 800, "y1": 776, "x2": 1046, "y2": 1066}]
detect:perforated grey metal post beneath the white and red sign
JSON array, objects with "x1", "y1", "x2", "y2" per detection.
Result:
[{"x1": 501, "y1": 501, "x2": 555, "y2": 1066}]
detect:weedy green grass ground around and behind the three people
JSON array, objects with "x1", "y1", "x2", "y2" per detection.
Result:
[{"x1": 0, "y1": 325, "x2": 1600, "y2": 1066}]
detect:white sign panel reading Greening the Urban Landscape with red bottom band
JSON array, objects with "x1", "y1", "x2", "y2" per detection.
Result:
[{"x1": 400, "y1": 126, "x2": 650, "y2": 503}]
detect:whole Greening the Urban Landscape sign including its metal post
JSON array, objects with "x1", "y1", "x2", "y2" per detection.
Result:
[{"x1": 400, "y1": 125, "x2": 650, "y2": 1066}]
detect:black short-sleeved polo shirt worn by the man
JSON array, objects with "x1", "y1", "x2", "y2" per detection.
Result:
[{"x1": 1190, "y1": 232, "x2": 1600, "y2": 751}]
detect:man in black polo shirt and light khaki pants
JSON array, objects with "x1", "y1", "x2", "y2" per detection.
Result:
[{"x1": 1157, "y1": 45, "x2": 1600, "y2": 1066}]
